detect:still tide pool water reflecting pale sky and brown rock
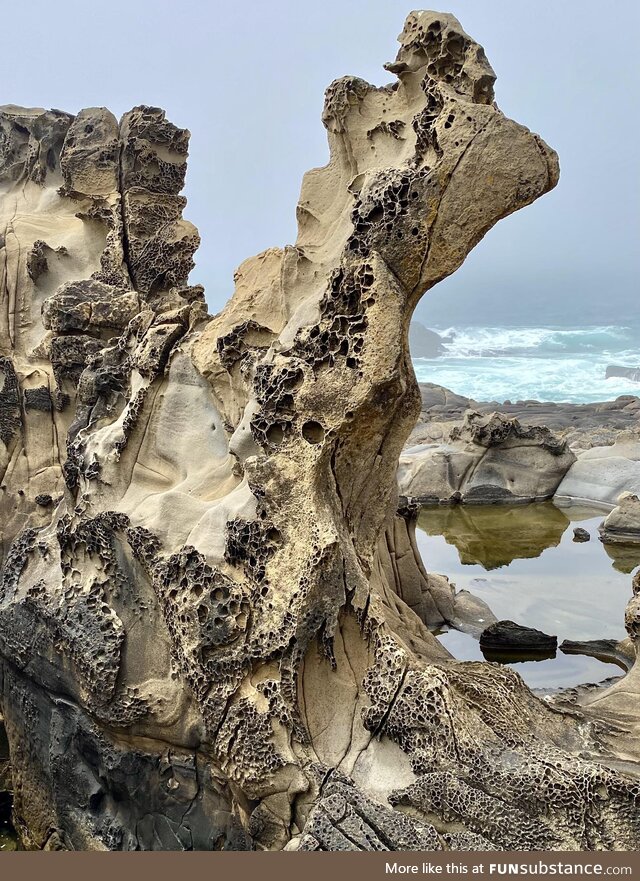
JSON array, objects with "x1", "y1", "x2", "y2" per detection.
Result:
[{"x1": 416, "y1": 502, "x2": 640, "y2": 688}]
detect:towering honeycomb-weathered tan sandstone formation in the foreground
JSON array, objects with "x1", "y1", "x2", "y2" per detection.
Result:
[{"x1": 0, "y1": 12, "x2": 640, "y2": 850}]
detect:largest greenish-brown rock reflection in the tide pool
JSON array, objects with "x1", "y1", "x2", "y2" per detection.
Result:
[{"x1": 418, "y1": 502, "x2": 569, "y2": 569}]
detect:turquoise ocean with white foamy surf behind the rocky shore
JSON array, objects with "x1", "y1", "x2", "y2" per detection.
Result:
[{"x1": 413, "y1": 325, "x2": 640, "y2": 404}]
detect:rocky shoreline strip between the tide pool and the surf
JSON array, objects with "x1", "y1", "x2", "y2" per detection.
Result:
[{"x1": 398, "y1": 383, "x2": 640, "y2": 512}]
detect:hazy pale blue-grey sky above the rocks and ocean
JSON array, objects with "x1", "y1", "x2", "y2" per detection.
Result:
[{"x1": 0, "y1": 0, "x2": 640, "y2": 327}]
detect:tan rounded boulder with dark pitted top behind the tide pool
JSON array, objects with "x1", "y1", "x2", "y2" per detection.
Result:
[{"x1": 398, "y1": 410, "x2": 576, "y2": 504}]
